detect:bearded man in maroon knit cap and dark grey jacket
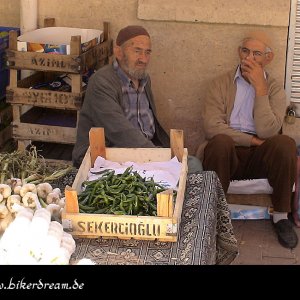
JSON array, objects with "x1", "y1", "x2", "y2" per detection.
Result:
[{"x1": 72, "y1": 25, "x2": 202, "y2": 172}]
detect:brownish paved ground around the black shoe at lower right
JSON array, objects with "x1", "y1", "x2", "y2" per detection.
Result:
[{"x1": 232, "y1": 220, "x2": 300, "y2": 265}]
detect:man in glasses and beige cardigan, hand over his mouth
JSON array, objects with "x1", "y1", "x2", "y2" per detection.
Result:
[{"x1": 197, "y1": 31, "x2": 298, "y2": 248}]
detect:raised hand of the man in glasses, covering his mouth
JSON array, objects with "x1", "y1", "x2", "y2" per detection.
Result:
[{"x1": 241, "y1": 57, "x2": 268, "y2": 96}]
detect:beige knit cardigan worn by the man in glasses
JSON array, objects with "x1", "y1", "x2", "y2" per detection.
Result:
[{"x1": 196, "y1": 69, "x2": 286, "y2": 160}]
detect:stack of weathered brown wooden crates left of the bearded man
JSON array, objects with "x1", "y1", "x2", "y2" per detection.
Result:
[{"x1": 6, "y1": 19, "x2": 112, "y2": 157}]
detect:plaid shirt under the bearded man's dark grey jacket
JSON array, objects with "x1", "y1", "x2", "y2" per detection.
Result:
[{"x1": 113, "y1": 60, "x2": 155, "y2": 140}]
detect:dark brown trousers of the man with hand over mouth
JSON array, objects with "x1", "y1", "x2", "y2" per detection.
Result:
[{"x1": 203, "y1": 134, "x2": 297, "y2": 212}]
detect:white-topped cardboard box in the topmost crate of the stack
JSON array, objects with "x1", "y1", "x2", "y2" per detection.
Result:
[{"x1": 17, "y1": 27, "x2": 104, "y2": 55}]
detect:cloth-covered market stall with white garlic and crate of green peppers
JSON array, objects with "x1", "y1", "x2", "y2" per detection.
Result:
[{"x1": 0, "y1": 129, "x2": 238, "y2": 265}]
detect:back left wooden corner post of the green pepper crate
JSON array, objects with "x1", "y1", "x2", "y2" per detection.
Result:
[{"x1": 89, "y1": 128, "x2": 106, "y2": 167}]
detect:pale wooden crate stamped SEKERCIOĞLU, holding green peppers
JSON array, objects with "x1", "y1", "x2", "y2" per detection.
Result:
[{"x1": 62, "y1": 128, "x2": 187, "y2": 242}]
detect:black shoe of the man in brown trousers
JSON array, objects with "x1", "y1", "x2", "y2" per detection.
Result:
[{"x1": 273, "y1": 219, "x2": 298, "y2": 249}]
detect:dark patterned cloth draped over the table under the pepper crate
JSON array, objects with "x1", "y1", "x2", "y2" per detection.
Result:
[{"x1": 70, "y1": 171, "x2": 238, "y2": 265}]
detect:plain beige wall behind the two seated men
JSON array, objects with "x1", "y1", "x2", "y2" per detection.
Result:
[{"x1": 0, "y1": 0, "x2": 290, "y2": 153}]
